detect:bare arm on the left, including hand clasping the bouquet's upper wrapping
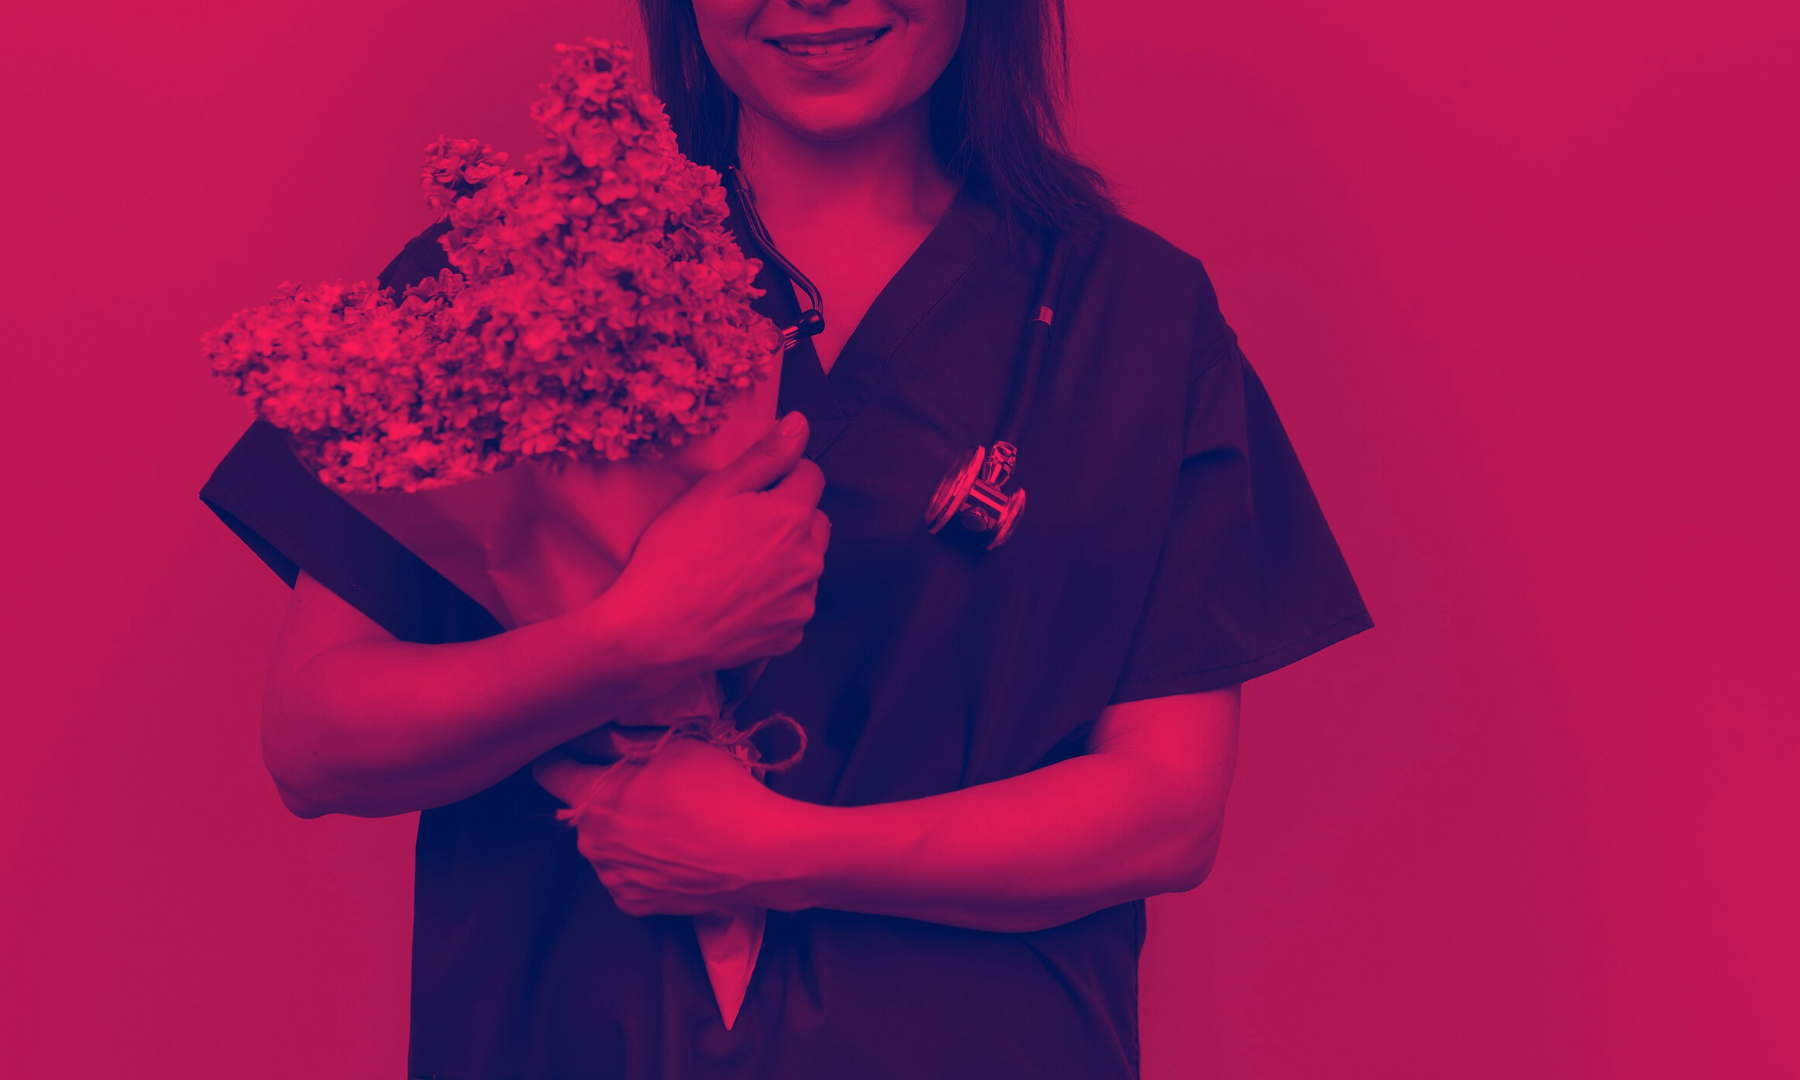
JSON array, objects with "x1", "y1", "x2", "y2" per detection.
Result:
[{"x1": 263, "y1": 414, "x2": 830, "y2": 817}]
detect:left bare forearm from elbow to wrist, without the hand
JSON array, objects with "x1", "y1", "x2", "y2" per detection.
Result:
[{"x1": 263, "y1": 586, "x2": 686, "y2": 817}]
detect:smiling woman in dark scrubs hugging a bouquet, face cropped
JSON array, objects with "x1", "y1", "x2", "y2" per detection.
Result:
[{"x1": 203, "y1": 0, "x2": 1370, "y2": 1080}]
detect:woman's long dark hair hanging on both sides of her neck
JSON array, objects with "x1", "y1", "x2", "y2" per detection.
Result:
[{"x1": 637, "y1": 0, "x2": 1118, "y2": 238}]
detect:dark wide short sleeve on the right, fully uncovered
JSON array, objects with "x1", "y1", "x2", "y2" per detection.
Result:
[{"x1": 1112, "y1": 320, "x2": 1373, "y2": 704}]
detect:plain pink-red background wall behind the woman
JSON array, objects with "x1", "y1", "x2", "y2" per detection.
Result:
[{"x1": 0, "y1": 0, "x2": 1800, "y2": 1080}]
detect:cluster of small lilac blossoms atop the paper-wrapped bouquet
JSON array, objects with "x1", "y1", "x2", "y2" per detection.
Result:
[{"x1": 205, "y1": 40, "x2": 781, "y2": 491}]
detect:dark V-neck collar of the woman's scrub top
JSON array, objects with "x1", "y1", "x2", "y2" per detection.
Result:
[{"x1": 725, "y1": 184, "x2": 999, "y2": 461}]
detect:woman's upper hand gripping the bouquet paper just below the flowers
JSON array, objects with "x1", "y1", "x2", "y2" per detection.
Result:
[{"x1": 580, "y1": 412, "x2": 832, "y2": 671}]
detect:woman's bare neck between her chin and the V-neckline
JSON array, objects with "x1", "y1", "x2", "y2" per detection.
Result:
[{"x1": 738, "y1": 99, "x2": 956, "y2": 234}]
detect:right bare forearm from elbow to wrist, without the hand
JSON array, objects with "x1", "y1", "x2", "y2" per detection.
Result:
[{"x1": 765, "y1": 752, "x2": 1229, "y2": 932}]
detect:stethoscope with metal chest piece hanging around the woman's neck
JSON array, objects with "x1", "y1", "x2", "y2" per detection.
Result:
[{"x1": 727, "y1": 166, "x2": 1069, "y2": 551}]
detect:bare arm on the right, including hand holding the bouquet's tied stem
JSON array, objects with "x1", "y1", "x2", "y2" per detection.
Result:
[{"x1": 538, "y1": 686, "x2": 1238, "y2": 932}]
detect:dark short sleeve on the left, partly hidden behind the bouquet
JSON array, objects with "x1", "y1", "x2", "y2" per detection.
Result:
[{"x1": 200, "y1": 216, "x2": 500, "y2": 644}]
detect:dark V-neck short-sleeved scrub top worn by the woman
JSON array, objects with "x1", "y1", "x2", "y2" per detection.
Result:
[{"x1": 202, "y1": 172, "x2": 1370, "y2": 1080}]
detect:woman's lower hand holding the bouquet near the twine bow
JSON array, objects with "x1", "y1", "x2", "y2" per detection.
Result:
[{"x1": 531, "y1": 738, "x2": 805, "y2": 916}]
